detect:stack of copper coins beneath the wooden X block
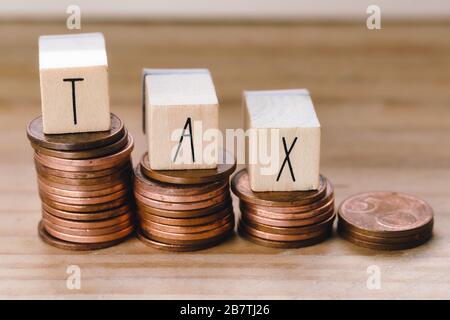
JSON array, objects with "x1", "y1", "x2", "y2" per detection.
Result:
[{"x1": 231, "y1": 169, "x2": 335, "y2": 248}]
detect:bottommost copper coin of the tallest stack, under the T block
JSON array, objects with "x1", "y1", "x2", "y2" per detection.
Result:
[{"x1": 38, "y1": 221, "x2": 127, "y2": 251}]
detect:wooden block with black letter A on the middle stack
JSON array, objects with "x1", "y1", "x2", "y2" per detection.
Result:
[{"x1": 143, "y1": 69, "x2": 219, "y2": 170}]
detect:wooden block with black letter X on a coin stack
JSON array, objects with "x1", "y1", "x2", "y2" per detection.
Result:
[{"x1": 243, "y1": 89, "x2": 320, "y2": 191}]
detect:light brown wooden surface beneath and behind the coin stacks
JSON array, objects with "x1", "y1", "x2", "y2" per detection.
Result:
[{"x1": 0, "y1": 22, "x2": 450, "y2": 299}]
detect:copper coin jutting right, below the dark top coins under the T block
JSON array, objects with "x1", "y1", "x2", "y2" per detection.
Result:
[{"x1": 34, "y1": 134, "x2": 134, "y2": 171}]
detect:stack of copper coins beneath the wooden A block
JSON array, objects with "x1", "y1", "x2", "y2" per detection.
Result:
[{"x1": 134, "y1": 153, "x2": 236, "y2": 251}]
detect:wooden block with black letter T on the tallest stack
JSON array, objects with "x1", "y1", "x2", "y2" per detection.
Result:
[{"x1": 39, "y1": 33, "x2": 111, "y2": 134}]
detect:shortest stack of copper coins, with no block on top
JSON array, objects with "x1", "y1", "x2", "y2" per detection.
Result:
[{"x1": 338, "y1": 192, "x2": 433, "y2": 250}]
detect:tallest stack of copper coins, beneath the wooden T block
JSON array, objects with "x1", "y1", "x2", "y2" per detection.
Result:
[{"x1": 27, "y1": 114, "x2": 133, "y2": 250}]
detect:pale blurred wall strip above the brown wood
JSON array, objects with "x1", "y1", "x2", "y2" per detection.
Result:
[{"x1": 0, "y1": 0, "x2": 450, "y2": 20}]
